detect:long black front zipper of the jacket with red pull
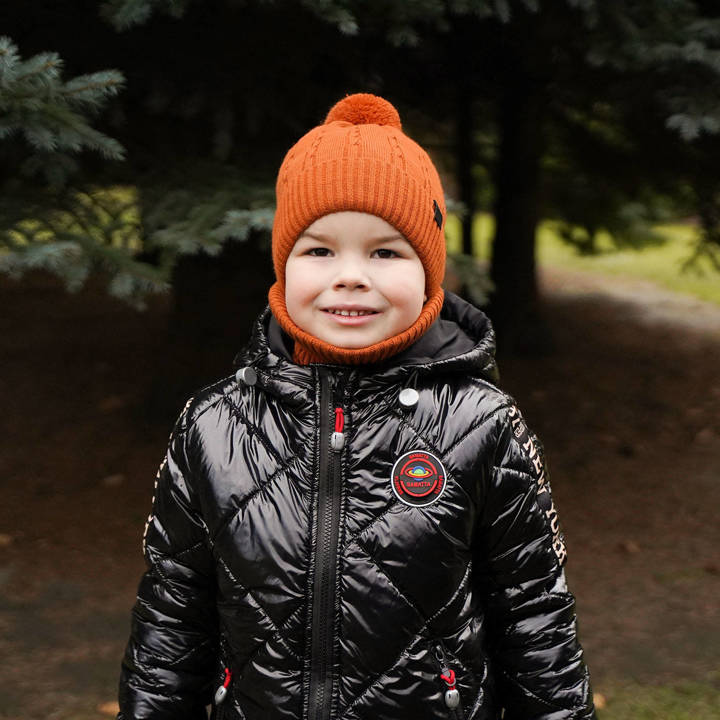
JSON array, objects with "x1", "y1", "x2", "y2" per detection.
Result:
[{"x1": 308, "y1": 369, "x2": 345, "y2": 720}]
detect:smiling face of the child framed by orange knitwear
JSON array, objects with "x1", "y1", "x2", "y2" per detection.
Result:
[{"x1": 285, "y1": 211, "x2": 425, "y2": 348}]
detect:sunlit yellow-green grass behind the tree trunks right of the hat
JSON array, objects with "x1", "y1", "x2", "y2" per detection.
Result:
[{"x1": 446, "y1": 214, "x2": 720, "y2": 305}]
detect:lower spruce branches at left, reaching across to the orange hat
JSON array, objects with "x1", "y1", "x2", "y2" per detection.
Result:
[{"x1": 0, "y1": 180, "x2": 274, "y2": 310}]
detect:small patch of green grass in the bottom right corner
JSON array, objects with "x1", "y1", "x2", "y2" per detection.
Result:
[{"x1": 597, "y1": 681, "x2": 720, "y2": 720}]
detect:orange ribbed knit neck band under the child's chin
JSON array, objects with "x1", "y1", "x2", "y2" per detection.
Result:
[{"x1": 268, "y1": 282, "x2": 444, "y2": 365}]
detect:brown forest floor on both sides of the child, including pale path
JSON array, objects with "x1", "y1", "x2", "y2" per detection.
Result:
[{"x1": 0, "y1": 271, "x2": 720, "y2": 720}]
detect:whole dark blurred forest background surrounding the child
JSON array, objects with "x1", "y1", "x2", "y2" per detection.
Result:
[{"x1": 0, "y1": 0, "x2": 720, "y2": 720}]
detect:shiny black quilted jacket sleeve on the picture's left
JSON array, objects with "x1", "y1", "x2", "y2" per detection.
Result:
[{"x1": 118, "y1": 403, "x2": 218, "y2": 720}]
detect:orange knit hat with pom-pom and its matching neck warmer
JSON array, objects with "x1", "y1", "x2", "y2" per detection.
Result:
[{"x1": 269, "y1": 93, "x2": 445, "y2": 364}]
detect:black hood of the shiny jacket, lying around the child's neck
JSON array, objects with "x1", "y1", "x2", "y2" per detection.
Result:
[{"x1": 234, "y1": 291, "x2": 498, "y2": 395}]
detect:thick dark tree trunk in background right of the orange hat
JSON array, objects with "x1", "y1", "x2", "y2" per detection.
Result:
[{"x1": 489, "y1": 73, "x2": 550, "y2": 352}]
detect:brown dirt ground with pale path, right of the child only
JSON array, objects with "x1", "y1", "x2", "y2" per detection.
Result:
[{"x1": 524, "y1": 272, "x2": 720, "y2": 686}]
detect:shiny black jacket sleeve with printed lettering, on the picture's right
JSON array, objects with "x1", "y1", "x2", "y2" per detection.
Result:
[{"x1": 475, "y1": 407, "x2": 595, "y2": 720}]
